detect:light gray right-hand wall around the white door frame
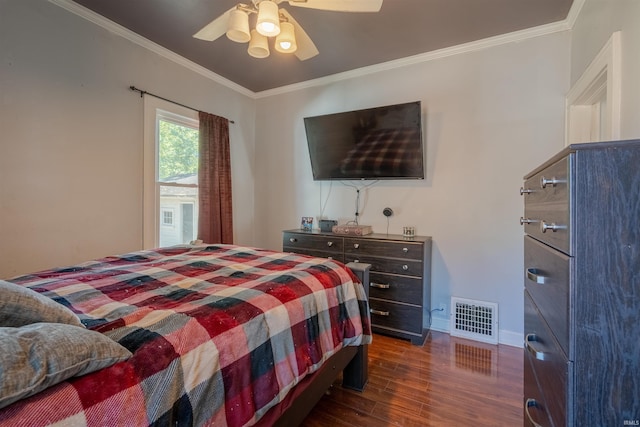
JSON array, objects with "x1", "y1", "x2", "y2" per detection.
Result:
[{"x1": 571, "y1": 0, "x2": 640, "y2": 139}]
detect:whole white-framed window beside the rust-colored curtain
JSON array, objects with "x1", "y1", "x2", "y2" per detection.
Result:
[{"x1": 143, "y1": 97, "x2": 198, "y2": 248}]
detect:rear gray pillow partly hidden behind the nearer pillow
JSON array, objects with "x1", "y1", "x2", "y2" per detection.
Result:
[{"x1": 0, "y1": 280, "x2": 82, "y2": 327}]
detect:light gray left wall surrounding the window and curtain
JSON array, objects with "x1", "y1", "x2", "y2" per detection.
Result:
[{"x1": 0, "y1": 0, "x2": 255, "y2": 278}]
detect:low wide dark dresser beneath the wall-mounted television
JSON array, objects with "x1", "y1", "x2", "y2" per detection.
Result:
[{"x1": 282, "y1": 230, "x2": 431, "y2": 345}]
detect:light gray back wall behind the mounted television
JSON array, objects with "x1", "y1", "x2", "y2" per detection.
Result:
[{"x1": 255, "y1": 32, "x2": 570, "y2": 345}]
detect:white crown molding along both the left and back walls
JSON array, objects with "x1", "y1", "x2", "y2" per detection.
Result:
[{"x1": 48, "y1": 0, "x2": 586, "y2": 99}]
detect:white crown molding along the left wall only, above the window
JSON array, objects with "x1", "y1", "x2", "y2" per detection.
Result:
[{"x1": 49, "y1": 0, "x2": 255, "y2": 98}]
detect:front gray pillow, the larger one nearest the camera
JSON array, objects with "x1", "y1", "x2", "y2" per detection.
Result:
[{"x1": 0, "y1": 323, "x2": 131, "y2": 408}]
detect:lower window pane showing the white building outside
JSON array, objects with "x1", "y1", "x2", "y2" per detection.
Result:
[{"x1": 159, "y1": 185, "x2": 198, "y2": 246}]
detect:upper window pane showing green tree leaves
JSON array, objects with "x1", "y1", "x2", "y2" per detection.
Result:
[{"x1": 158, "y1": 119, "x2": 198, "y2": 184}]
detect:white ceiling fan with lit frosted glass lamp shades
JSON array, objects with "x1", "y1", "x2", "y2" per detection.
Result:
[{"x1": 193, "y1": 0, "x2": 383, "y2": 61}]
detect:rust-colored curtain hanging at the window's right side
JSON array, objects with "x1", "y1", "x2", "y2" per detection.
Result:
[{"x1": 198, "y1": 111, "x2": 233, "y2": 243}]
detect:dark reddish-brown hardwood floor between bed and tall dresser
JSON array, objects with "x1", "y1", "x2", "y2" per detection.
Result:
[{"x1": 302, "y1": 331, "x2": 524, "y2": 427}]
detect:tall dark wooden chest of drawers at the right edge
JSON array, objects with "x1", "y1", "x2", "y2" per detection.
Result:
[{"x1": 520, "y1": 140, "x2": 640, "y2": 426}]
